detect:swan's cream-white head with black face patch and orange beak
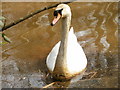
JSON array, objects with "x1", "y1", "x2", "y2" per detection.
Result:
[{"x1": 51, "y1": 4, "x2": 71, "y2": 26}]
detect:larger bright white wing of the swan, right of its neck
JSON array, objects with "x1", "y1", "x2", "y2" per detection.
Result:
[{"x1": 67, "y1": 27, "x2": 87, "y2": 73}]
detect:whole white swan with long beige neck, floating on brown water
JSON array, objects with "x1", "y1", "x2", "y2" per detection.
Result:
[{"x1": 46, "y1": 4, "x2": 87, "y2": 80}]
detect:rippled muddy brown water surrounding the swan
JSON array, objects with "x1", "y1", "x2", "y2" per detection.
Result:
[{"x1": 2, "y1": 2, "x2": 118, "y2": 88}]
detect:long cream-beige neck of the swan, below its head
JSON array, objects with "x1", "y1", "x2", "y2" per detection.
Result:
[{"x1": 54, "y1": 16, "x2": 71, "y2": 74}]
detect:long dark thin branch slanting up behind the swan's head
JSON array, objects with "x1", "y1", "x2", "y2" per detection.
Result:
[{"x1": 2, "y1": 0, "x2": 76, "y2": 31}]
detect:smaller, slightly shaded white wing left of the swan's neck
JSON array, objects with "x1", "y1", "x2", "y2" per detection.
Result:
[{"x1": 46, "y1": 41, "x2": 61, "y2": 72}]
